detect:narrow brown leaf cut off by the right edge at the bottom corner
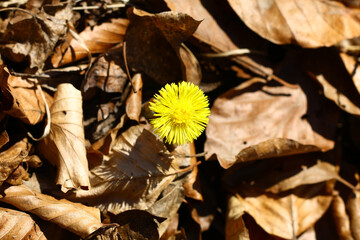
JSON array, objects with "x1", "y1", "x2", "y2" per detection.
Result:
[{"x1": 346, "y1": 188, "x2": 360, "y2": 240}]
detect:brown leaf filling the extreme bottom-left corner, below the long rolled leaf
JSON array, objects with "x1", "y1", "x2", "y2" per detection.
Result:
[{"x1": 0, "y1": 208, "x2": 46, "y2": 240}]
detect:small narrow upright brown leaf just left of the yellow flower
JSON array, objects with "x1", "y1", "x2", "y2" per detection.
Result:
[{"x1": 125, "y1": 73, "x2": 143, "y2": 122}]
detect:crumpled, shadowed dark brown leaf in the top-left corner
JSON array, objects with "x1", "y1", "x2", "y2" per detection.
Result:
[{"x1": 0, "y1": 4, "x2": 72, "y2": 69}]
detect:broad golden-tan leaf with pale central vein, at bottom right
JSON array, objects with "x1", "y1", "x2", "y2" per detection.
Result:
[{"x1": 233, "y1": 184, "x2": 332, "y2": 239}]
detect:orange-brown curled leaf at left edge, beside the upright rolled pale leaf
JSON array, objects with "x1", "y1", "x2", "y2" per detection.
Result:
[{"x1": 0, "y1": 66, "x2": 52, "y2": 125}]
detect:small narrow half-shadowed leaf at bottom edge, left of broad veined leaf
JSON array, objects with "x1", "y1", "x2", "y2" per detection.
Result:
[{"x1": 225, "y1": 195, "x2": 250, "y2": 240}]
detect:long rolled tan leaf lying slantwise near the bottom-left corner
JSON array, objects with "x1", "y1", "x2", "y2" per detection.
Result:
[{"x1": 0, "y1": 186, "x2": 102, "y2": 237}]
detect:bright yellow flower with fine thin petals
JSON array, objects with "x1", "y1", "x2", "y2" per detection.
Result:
[{"x1": 150, "y1": 82, "x2": 210, "y2": 144}]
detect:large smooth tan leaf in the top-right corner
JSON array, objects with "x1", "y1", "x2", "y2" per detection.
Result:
[{"x1": 228, "y1": 0, "x2": 360, "y2": 48}]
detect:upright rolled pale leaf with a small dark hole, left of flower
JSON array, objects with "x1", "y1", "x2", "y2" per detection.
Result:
[{"x1": 39, "y1": 83, "x2": 90, "y2": 192}]
